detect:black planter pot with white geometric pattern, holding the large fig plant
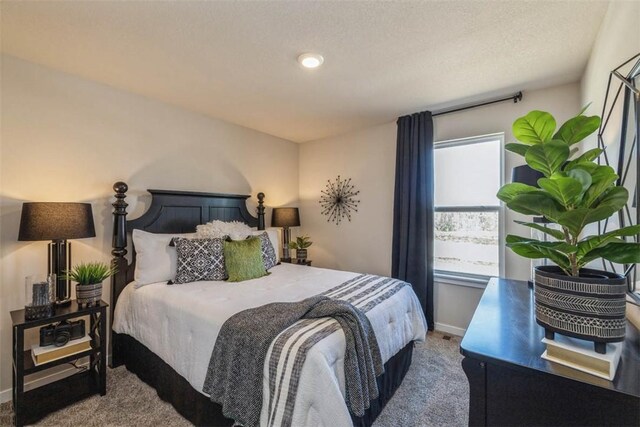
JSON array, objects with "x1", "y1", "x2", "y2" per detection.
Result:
[{"x1": 535, "y1": 265, "x2": 627, "y2": 354}]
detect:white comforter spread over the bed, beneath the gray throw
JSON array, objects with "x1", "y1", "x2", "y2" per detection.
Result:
[{"x1": 113, "y1": 264, "x2": 426, "y2": 427}]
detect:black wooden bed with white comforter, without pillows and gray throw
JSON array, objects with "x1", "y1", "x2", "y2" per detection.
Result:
[{"x1": 111, "y1": 182, "x2": 426, "y2": 426}]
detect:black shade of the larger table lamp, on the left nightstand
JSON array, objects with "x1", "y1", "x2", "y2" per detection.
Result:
[{"x1": 18, "y1": 202, "x2": 96, "y2": 241}]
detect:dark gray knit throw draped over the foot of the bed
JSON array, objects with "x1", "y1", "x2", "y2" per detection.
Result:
[{"x1": 203, "y1": 296, "x2": 384, "y2": 427}]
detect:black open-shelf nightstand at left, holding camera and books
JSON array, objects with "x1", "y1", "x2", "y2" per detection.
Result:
[{"x1": 11, "y1": 300, "x2": 109, "y2": 426}]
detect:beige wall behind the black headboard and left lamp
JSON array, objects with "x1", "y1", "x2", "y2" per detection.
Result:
[{"x1": 0, "y1": 56, "x2": 298, "y2": 399}]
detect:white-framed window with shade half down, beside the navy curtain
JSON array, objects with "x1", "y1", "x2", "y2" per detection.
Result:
[{"x1": 434, "y1": 134, "x2": 504, "y2": 279}]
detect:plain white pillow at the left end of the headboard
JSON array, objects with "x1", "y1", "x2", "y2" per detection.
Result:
[{"x1": 133, "y1": 230, "x2": 195, "y2": 288}]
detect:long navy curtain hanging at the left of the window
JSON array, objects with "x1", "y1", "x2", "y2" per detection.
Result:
[{"x1": 391, "y1": 111, "x2": 434, "y2": 330}]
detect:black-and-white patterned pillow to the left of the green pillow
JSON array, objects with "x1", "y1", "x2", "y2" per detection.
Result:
[{"x1": 169, "y1": 237, "x2": 227, "y2": 284}]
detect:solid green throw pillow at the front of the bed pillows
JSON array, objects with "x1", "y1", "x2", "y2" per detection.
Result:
[{"x1": 224, "y1": 237, "x2": 269, "y2": 282}]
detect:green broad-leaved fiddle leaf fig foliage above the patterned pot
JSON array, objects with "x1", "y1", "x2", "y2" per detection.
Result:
[{"x1": 497, "y1": 106, "x2": 640, "y2": 276}]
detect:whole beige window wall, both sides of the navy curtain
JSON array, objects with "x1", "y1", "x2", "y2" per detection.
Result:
[{"x1": 299, "y1": 84, "x2": 580, "y2": 332}]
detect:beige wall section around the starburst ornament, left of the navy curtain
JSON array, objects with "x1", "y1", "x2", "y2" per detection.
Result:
[{"x1": 298, "y1": 122, "x2": 396, "y2": 275}]
